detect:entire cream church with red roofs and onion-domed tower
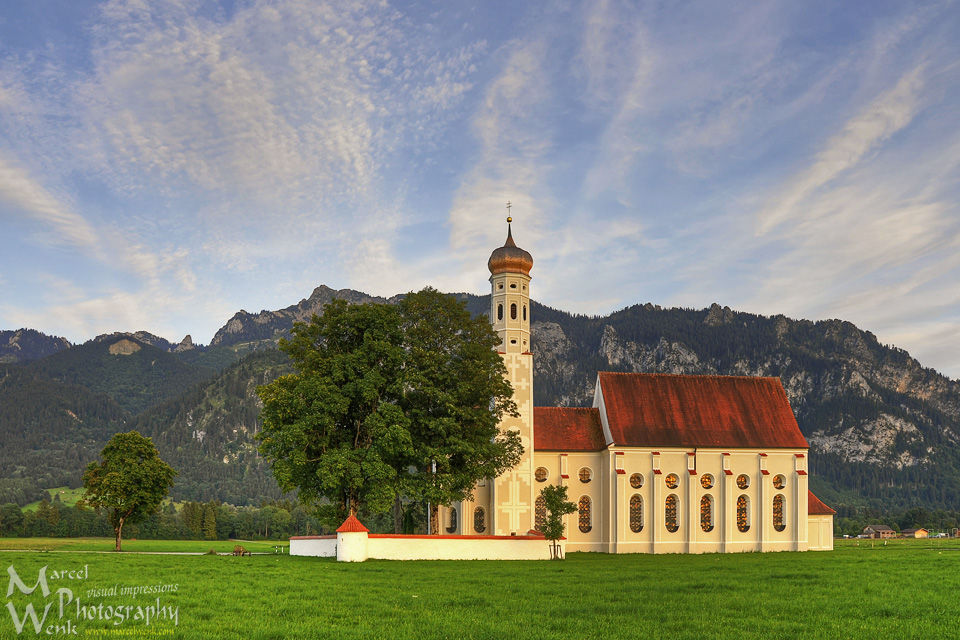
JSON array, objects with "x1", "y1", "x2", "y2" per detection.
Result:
[{"x1": 440, "y1": 218, "x2": 834, "y2": 553}]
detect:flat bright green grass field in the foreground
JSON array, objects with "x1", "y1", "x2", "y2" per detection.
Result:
[{"x1": 0, "y1": 540, "x2": 960, "y2": 639}]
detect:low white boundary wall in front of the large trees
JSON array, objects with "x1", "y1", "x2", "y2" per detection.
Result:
[{"x1": 290, "y1": 532, "x2": 565, "y2": 562}]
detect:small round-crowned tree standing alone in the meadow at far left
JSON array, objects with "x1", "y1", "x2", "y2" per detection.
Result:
[{"x1": 83, "y1": 431, "x2": 177, "y2": 551}]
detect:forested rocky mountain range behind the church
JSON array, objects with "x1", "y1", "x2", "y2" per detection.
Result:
[{"x1": 0, "y1": 286, "x2": 960, "y2": 516}]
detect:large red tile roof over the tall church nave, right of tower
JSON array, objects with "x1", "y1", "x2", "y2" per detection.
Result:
[{"x1": 599, "y1": 372, "x2": 808, "y2": 449}]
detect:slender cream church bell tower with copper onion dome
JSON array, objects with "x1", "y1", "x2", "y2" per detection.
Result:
[{"x1": 487, "y1": 218, "x2": 535, "y2": 535}]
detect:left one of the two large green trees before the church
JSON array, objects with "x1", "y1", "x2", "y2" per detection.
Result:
[{"x1": 257, "y1": 300, "x2": 411, "y2": 526}]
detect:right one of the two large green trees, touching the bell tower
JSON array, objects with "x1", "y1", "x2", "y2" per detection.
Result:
[{"x1": 400, "y1": 288, "x2": 523, "y2": 533}]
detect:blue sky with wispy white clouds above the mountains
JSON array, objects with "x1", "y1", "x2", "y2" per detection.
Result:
[{"x1": 0, "y1": 0, "x2": 960, "y2": 378}]
